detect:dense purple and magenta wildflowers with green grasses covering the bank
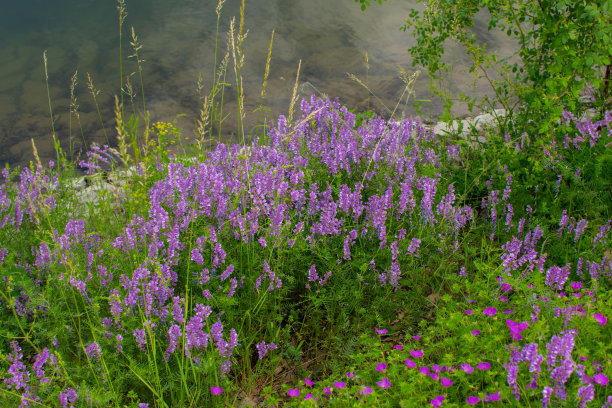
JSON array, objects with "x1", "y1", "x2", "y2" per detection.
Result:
[{"x1": 0, "y1": 1, "x2": 612, "y2": 408}]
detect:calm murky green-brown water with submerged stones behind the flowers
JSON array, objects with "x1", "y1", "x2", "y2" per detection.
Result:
[{"x1": 0, "y1": 0, "x2": 510, "y2": 166}]
